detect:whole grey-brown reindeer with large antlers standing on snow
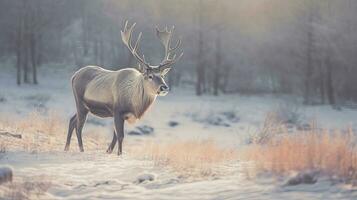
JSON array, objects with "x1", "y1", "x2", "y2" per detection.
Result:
[{"x1": 64, "y1": 21, "x2": 183, "y2": 155}]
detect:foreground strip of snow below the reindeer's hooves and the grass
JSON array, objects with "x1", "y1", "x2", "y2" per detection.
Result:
[{"x1": 0, "y1": 152, "x2": 357, "y2": 199}]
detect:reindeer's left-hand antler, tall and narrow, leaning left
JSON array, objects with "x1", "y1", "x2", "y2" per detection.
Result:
[{"x1": 120, "y1": 21, "x2": 151, "y2": 68}]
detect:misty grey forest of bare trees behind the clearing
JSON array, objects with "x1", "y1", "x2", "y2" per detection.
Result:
[{"x1": 0, "y1": 0, "x2": 357, "y2": 105}]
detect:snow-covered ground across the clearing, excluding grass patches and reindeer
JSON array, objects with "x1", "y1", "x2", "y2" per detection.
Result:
[{"x1": 0, "y1": 67, "x2": 357, "y2": 199}]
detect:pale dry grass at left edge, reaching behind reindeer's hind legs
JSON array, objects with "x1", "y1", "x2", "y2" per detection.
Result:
[{"x1": 0, "y1": 111, "x2": 106, "y2": 153}]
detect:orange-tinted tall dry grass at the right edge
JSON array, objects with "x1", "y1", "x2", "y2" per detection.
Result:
[{"x1": 245, "y1": 118, "x2": 357, "y2": 180}]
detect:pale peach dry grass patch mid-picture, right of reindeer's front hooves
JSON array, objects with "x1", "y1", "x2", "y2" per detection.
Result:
[{"x1": 130, "y1": 140, "x2": 237, "y2": 177}]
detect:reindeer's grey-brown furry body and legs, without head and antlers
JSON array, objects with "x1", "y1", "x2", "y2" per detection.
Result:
[{"x1": 65, "y1": 66, "x2": 166, "y2": 155}]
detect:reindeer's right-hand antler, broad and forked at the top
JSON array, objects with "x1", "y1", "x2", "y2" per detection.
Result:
[{"x1": 156, "y1": 26, "x2": 183, "y2": 70}]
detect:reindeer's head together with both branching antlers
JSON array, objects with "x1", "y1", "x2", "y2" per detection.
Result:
[{"x1": 121, "y1": 21, "x2": 183, "y2": 96}]
